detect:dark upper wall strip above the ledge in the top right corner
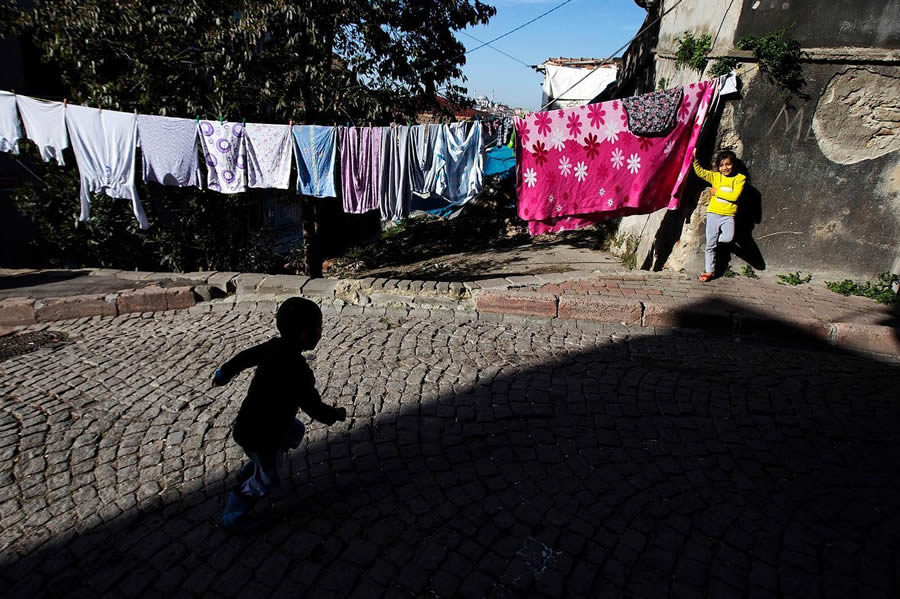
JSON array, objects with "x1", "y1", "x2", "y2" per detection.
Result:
[{"x1": 736, "y1": 0, "x2": 900, "y2": 49}]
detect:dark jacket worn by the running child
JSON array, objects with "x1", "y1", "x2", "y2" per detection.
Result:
[{"x1": 220, "y1": 337, "x2": 339, "y2": 451}]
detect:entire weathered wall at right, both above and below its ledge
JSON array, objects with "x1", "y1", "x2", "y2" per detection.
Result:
[{"x1": 619, "y1": 0, "x2": 900, "y2": 278}]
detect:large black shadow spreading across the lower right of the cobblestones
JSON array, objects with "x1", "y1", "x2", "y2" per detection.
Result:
[{"x1": 3, "y1": 306, "x2": 900, "y2": 598}]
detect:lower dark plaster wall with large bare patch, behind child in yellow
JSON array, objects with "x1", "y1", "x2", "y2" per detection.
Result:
[{"x1": 656, "y1": 65, "x2": 900, "y2": 278}]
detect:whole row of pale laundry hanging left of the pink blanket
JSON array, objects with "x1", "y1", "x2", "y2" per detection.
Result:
[{"x1": 0, "y1": 91, "x2": 511, "y2": 228}]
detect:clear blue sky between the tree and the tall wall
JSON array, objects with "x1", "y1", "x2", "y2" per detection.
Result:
[{"x1": 456, "y1": 0, "x2": 647, "y2": 110}]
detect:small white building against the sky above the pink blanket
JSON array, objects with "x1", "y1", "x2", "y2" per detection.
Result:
[{"x1": 534, "y1": 58, "x2": 619, "y2": 110}]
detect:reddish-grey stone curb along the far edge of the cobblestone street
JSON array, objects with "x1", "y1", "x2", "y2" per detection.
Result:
[{"x1": 0, "y1": 269, "x2": 900, "y2": 355}]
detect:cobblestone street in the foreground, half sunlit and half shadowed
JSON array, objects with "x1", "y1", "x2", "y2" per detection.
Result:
[{"x1": 0, "y1": 309, "x2": 900, "y2": 599}]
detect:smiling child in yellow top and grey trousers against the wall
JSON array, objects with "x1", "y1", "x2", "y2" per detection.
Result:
[{"x1": 694, "y1": 148, "x2": 747, "y2": 283}]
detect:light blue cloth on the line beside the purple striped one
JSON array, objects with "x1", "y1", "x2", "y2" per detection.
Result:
[{"x1": 293, "y1": 125, "x2": 337, "y2": 198}]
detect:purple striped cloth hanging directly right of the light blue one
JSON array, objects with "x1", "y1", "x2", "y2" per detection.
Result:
[{"x1": 340, "y1": 127, "x2": 383, "y2": 214}]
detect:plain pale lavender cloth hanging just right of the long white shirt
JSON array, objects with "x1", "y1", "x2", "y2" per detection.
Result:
[{"x1": 138, "y1": 114, "x2": 201, "y2": 187}]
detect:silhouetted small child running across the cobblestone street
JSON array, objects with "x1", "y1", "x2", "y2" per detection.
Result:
[{"x1": 213, "y1": 297, "x2": 347, "y2": 531}]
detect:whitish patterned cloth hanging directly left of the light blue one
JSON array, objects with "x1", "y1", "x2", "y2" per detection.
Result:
[{"x1": 245, "y1": 123, "x2": 294, "y2": 189}]
